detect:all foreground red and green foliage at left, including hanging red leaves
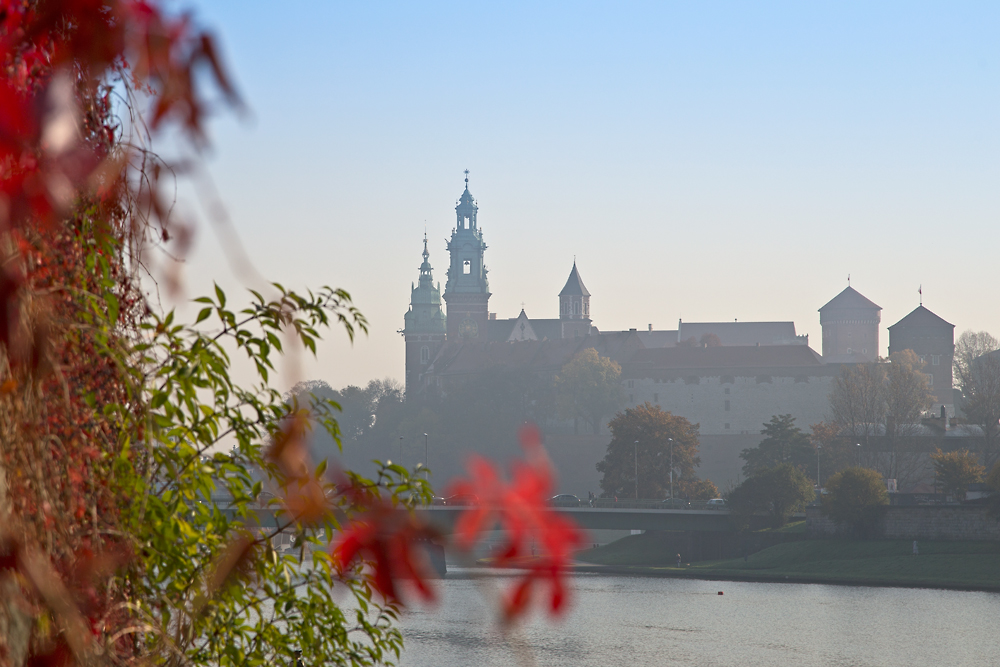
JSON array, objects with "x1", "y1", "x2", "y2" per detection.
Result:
[{"x1": 0, "y1": 0, "x2": 579, "y2": 667}]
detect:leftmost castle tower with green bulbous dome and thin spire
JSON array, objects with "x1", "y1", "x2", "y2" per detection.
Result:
[{"x1": 402, "y1": 232, "x2": 447, "y2": 393}]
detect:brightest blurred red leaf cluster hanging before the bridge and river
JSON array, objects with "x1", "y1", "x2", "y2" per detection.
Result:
[{"x1": 449, "y1": 426, "x2": 583, "y2": 619}]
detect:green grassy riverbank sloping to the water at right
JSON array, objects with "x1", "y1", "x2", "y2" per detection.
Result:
[{"x1": 576, "y1": 533, "x2": 1000, "y2": 592}]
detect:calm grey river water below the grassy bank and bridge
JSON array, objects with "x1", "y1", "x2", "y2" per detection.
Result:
[{"x1": 400, "y1": 570, "x2": 1000, "y2": 667}]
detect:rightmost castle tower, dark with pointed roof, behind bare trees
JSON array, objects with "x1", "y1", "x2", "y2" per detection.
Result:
[{"x1": 889, "y1": 304, "x2": 955, "y2": 417}]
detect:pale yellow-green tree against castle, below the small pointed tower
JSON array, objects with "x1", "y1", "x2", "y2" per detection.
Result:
[{"x1": 555, "y1": 347, "x2": 625, "y2": 433}]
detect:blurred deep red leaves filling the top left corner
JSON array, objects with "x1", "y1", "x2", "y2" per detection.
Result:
[{"x1": 0, "y1": 0, "x2": 237, "y2": 354}]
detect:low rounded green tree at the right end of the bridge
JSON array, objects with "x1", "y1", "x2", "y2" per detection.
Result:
[{"x1": 726, "y1": 463, "x2": 816, "y2": 528}]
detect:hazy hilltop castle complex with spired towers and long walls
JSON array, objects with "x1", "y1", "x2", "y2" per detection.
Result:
[{"x1": 401, "y1": 172, "x2": 955, "y2": 482}]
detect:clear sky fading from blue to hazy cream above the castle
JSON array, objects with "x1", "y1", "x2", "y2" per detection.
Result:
[{"x1": 170, "y1": 0, "x2": 1000, "y2": 388}]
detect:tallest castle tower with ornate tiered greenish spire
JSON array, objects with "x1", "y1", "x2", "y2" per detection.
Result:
[{"x1": 444, "y1": 169, "x2": 490, "y2": 342}]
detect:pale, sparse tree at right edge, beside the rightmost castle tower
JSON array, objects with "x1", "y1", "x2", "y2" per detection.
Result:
[{"x1": 954, "y1": 331, "x2": 1000, "y2": 466}]
